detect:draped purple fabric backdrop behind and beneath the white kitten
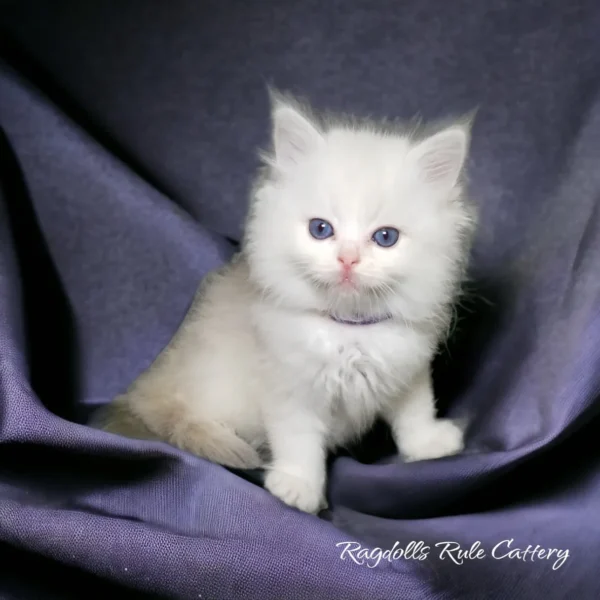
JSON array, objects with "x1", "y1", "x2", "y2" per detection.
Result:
[{"x1": 0, "y1": 0, "x2": 600, "y2": 600}]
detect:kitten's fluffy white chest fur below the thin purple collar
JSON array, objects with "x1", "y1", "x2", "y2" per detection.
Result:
[{"x1": 255, "y1": 316, "x2": 431, "y2": 446}]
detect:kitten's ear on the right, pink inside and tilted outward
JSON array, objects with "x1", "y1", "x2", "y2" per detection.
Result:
[{"x1": 410, "y1": 125, "x2": 469, "y2": 189}]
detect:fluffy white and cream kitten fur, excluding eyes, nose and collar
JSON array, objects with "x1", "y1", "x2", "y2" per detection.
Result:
[{"x1": 98, "y1": 94, "x2": 475, "y2": 512}]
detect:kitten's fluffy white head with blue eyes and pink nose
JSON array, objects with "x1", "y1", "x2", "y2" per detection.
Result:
[{"x1": 245, "y1": 96, "x2": 474, "y2": 328}]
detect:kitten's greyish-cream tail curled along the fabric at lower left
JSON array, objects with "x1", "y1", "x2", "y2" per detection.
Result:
[{"x1": 92, "y1": 395, "x2": 263, "y2": 469}]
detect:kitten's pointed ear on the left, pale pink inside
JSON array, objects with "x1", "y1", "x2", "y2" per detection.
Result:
[{"x1": 271, "y1": 93, "x2": 323, "y2": 169}]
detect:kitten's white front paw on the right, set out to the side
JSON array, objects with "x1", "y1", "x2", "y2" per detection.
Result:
[{"x1": 400, "y1": 419, "x2": 464, "y2": 462}]
